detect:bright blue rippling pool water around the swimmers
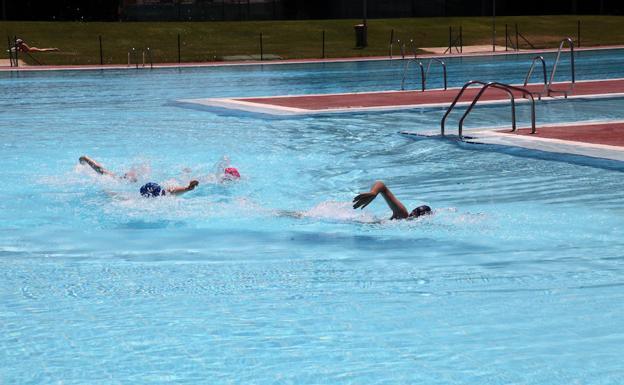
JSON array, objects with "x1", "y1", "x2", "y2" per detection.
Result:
[{"x1": 0, "y1": 51, "x2": 624, "y2": 385}]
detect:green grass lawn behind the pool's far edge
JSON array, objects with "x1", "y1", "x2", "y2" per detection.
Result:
[{"x1": 0, "y1": 16, "x2": 624, "y2": 64}]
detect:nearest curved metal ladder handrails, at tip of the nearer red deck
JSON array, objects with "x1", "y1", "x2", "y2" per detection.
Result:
[{"x1": 440, "y1": 80, "x2": 536, "y2": 140}]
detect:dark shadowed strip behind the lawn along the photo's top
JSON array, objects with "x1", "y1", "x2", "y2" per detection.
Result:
[{"x1": 0, "y1": 0, "x2": 624, "y2": 21}]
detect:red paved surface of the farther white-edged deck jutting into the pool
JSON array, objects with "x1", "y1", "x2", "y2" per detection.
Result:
[{"x1": 234, "y1": 79, "x2": 624, "y2": 111}]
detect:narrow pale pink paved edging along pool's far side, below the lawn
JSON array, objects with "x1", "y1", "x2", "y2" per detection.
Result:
[{"x1": 0, "y1": 45, "x2": 624, "y2": 72}]
